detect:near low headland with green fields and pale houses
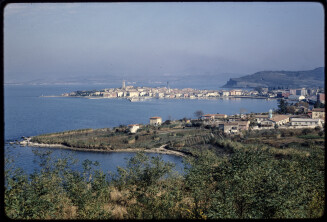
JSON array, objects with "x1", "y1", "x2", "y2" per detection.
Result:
[{"x1": 20, "y1": 108, "x2": 325, "y2": 156}]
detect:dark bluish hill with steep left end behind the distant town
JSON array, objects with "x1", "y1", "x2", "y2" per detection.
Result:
[{"x1": 222, "y1": 67, "x2": 325, "y2": 88}]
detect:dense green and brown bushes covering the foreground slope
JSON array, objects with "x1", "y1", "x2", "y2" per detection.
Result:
[{"x1": 5, "y1": 125, "x2": 325, "y2": 219}]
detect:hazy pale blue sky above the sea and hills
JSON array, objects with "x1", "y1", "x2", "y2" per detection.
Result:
[{"x1": 4, "y1": 2, "x2": 324, "y2": 82}]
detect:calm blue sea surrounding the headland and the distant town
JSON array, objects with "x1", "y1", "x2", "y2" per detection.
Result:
[{"x1": 3, "y1": 84, "x2": 277, "y2": 177}]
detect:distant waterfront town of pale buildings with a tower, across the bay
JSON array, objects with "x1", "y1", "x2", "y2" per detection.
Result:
[{"x1": 61, "y1": 81, "x2": 325, "y2": 105}]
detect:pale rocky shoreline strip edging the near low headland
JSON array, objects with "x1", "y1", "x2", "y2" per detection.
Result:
[{"x1": 19, "y1": 137, "x2": 186, "y2": 157}]
